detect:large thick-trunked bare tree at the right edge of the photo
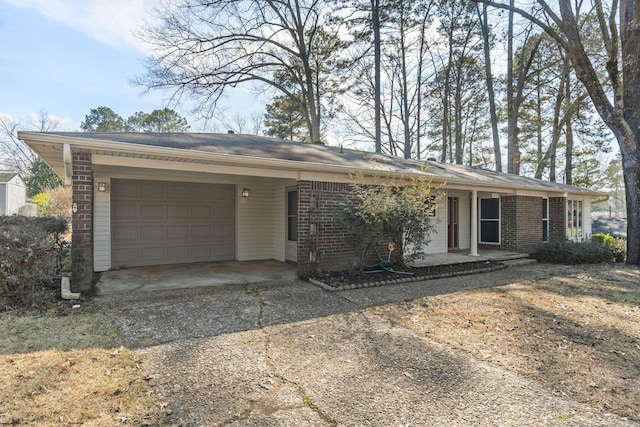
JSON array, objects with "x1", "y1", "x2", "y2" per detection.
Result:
[{"x1": 477, "y1": 0, "x2": 640, "y2": 264}]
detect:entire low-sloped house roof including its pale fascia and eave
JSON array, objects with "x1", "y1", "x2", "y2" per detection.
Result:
[{"x1": 19, "y1": 132, "x2": 605, "y2": 195}]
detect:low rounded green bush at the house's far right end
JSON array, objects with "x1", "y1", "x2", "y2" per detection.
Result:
[{"x1": 531, "y1": 240, "x2": 616, "y2": 264}]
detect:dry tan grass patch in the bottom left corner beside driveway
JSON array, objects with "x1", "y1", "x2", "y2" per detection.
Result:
[{"x1": 0, "y1": 303, "x2": 161, "y2": 426}]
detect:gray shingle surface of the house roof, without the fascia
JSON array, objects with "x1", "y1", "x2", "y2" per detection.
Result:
[{"x1": 42, "y1": 132, "x2": 594, "y2": 193}]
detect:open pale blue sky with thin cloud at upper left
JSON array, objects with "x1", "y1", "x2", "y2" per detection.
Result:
[{"x1": 0, "y1": 0, "x2": 260, "y2": 131}]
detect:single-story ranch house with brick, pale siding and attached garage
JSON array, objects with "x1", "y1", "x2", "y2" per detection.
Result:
[{"x1": 19, "y1": 132, "x2": 604, "y2": 290}]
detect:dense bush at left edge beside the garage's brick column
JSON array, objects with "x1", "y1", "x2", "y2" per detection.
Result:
[{"x1": 0, "y1": 215, "x2": 69, "y2": 307}]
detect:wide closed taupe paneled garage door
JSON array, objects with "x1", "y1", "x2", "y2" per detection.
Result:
[{"x1": 111, "y1": 179, "x2": 235, "y2": 267}]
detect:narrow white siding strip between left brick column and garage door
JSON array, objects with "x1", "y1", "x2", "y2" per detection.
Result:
[{"x1": 93, "y1": 177, "x2": 111, "y2": 271}]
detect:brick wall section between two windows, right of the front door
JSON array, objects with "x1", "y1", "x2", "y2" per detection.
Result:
[{"x1": 500, "y1": 196, "x2": 542, "y2": 253}]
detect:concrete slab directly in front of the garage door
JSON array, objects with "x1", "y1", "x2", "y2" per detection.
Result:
[{"x1": 96, "y1": 260, "x2": 297, "y2": 295}]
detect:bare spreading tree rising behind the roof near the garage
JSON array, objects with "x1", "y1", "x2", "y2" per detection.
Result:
[{"x1": 134, "y1": 0, "x2": 337, "y2": 141}]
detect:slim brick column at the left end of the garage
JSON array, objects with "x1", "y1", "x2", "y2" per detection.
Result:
[{"x1": 71, "y1": 153, "x2": 93, "y2": 292}]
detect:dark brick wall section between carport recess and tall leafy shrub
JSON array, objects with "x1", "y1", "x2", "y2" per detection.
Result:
[{"x1": 298, "y1": 181, "x2": 357, "y2": 277}]
